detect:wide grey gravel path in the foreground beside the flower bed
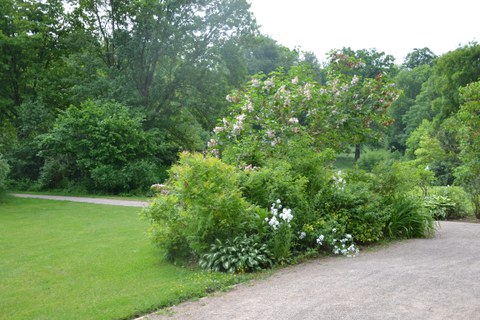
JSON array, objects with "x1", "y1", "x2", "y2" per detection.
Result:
[{"x1": 142, "y1": 222, "x2": 480, "y2": 320}]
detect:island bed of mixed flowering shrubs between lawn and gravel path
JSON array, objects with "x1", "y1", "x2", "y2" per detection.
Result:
[{"x1": 144, "y1": 64, "x2": 433, "y2": 272}]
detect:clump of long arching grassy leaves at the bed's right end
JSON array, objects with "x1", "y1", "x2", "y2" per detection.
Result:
[{"x1": 385, "y1": 196, "x2": 435, "y2": 238}]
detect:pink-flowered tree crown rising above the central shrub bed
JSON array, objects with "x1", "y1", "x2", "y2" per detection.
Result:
[{"x1": 208, "y1": 52, "x2": 398, "y2": 165}]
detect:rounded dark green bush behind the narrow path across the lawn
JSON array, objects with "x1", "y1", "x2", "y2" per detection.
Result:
[{"x1": 40, "y1": 101, "x2": 162, "y2": 193}]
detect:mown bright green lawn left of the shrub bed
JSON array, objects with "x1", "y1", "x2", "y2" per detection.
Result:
[{"x1": 0, "y1": 198, "x2": 249, "y2": 320}]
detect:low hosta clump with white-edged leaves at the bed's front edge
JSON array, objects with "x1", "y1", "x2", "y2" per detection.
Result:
[{"x1": 199, "y1": 235, "x2": 272, "y2": 273}]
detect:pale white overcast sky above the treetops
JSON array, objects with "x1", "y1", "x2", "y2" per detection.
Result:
[{"x1": 247, "y1": 0, "x2": 480, "y2": 64}]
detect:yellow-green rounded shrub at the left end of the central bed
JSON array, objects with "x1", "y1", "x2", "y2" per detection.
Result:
[{"x1": 144, "y1": 152, "x2": 255, "y2": 260}]
